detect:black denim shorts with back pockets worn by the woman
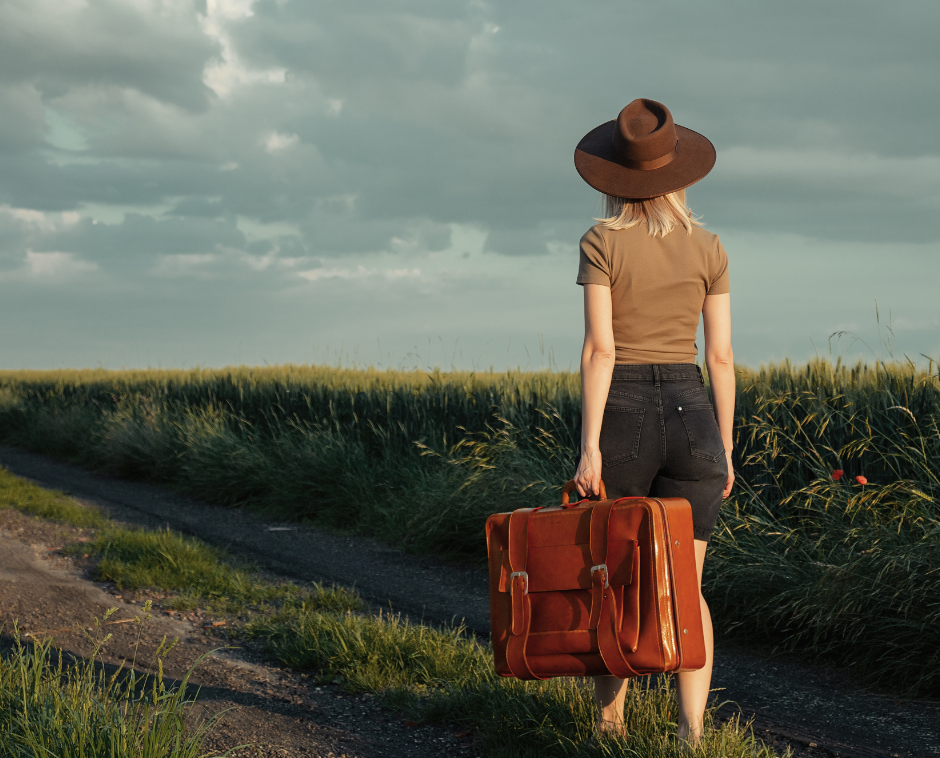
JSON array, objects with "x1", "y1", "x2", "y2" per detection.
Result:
[{"x1": 600, "y1": 363, "x2": 728, "y2": 542}]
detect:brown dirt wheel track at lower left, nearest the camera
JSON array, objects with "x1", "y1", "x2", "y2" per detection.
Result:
[{"x1": 0, "y1": 480, "x2": 475, "y2": 758}]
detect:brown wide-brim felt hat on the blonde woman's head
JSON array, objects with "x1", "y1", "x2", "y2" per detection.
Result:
[{"x1": 574, "y1": 98, "x2": 715, "y2": 200}]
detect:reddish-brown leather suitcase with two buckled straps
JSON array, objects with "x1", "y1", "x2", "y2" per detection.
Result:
[{"x1": 486, "y1": 482, "x2": 705, "y2": 679}]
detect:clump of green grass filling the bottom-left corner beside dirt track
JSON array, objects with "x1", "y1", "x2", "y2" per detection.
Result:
[{"x1": 0, "y1": 616, "x2": 231, "y2": 758}]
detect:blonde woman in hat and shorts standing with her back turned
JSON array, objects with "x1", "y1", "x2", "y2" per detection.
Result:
[{"x1": 574, "y1": 99, "x2": 735, "y2": 744}]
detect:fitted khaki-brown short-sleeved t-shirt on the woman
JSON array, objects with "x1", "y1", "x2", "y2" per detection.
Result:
[{"x1": 578, "y1": 223, "x2": 731, "y2": 363}]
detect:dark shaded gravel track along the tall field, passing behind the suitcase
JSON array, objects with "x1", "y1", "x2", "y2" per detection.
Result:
[{"x1": 0, "y1": 448, "x2": 940, "y2": 758}]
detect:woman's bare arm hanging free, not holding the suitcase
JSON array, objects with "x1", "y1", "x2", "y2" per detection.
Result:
[{"x1": 702, "y1": 293, "x2": 735, "y2": 497}]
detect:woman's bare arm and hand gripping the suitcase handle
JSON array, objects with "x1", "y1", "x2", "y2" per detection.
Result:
[{"x1": 574, "y1": 284, "x2": 615, "y2": 497}]
